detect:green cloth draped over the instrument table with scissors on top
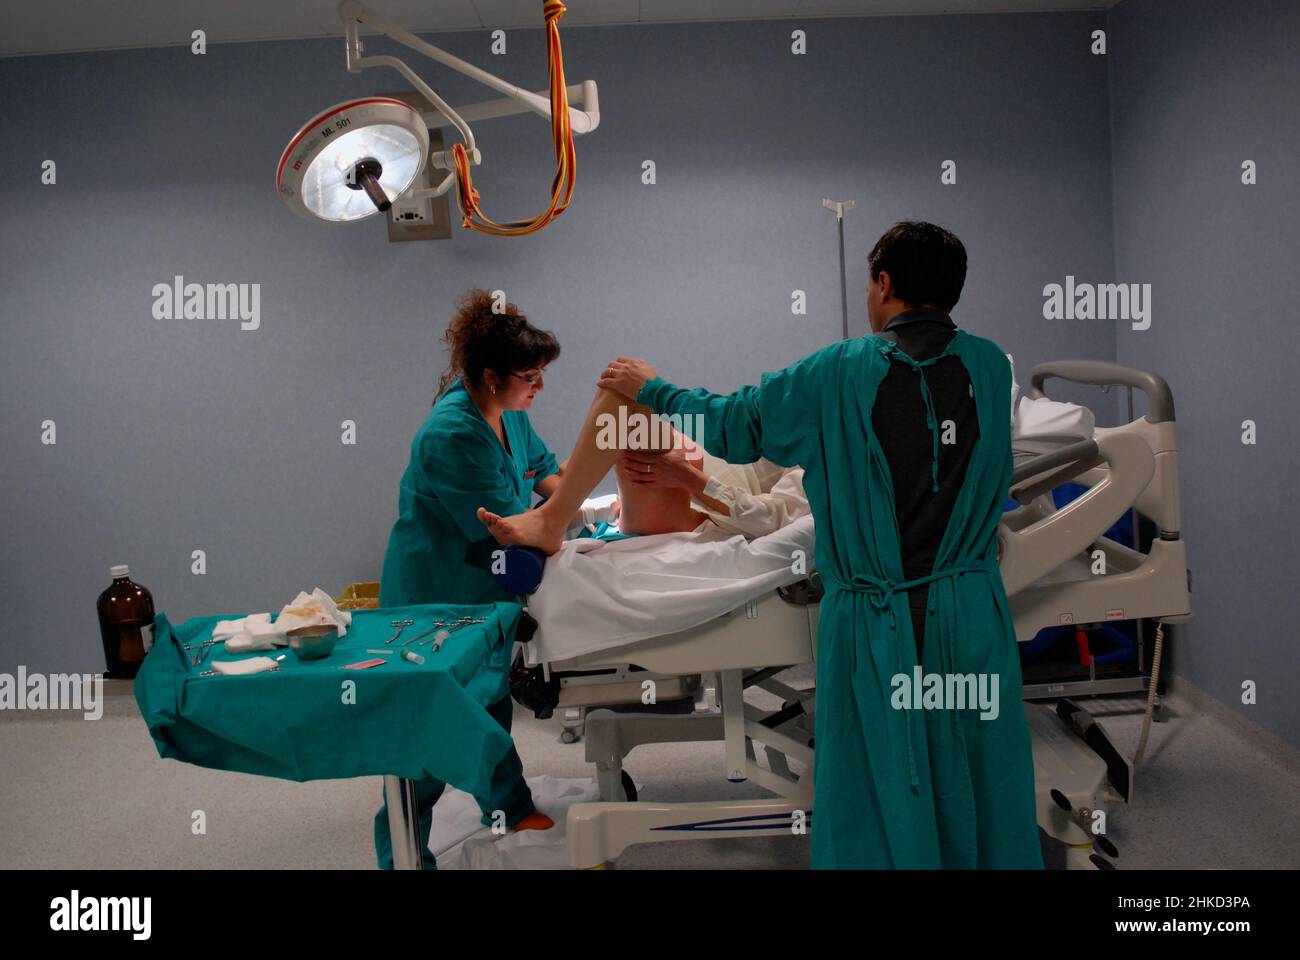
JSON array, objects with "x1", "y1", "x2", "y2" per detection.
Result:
[{"x1": 135, "y1": 601, "x2": 523, "y2": 795}]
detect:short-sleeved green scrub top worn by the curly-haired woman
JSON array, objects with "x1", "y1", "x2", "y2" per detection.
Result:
[{"x1": 380, "y1": 380, "x2": 559, "y2": 606}]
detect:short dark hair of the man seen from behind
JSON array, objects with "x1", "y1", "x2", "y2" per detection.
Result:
[{"x1": 867, "y1": 220, "x2": 966, "y2": 312}]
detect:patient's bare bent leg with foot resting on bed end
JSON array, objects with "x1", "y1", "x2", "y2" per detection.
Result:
[{"x1": 478, "y1": 389, "x2": 702, "y2": 554}]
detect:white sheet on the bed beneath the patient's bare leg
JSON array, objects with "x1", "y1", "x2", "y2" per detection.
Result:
[{"x1": 528, "y1": 516, "x2": 813, "y2": 663}]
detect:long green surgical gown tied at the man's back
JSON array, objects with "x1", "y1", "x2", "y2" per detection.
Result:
[{"x1": 637, "y1": 330, "x2": 1043, "y2": 869}]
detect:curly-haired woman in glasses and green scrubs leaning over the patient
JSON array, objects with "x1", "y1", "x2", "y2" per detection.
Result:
[{"x1": 374, "y1": 290, "x2": 560, "y2": 869}]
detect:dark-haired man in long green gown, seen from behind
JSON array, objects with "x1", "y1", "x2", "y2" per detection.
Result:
[{"x1": 601, "y1": 222, "x2": 1043, "y2": 869}]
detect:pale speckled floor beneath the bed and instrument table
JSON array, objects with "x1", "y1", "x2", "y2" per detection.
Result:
[{"x1": 0, "y1": 671, "x2": 1300, "y2": 869}]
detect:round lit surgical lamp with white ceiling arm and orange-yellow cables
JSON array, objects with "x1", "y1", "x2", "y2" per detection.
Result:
[{"x1": 276, "y1": 0, "x2": 601, "y2": 237}]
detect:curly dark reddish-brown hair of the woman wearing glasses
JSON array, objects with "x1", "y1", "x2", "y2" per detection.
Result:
[{"x1": 433, "y1": 289, "x2": 560, "y2": 403}]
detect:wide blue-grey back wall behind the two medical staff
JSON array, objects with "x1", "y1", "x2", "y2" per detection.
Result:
[{"x1": 0, "y1": 14, "x2": 1118, "y2": 671}]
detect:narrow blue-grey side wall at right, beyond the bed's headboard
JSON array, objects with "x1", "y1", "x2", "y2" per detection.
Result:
[{"x1": 1110, "y1": 0, "x2": 1300, "y2": 743}]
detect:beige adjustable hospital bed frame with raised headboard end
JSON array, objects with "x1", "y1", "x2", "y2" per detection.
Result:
[{"x1": 504, "y1": 360, "x2": 1191, "y2": 868}]
